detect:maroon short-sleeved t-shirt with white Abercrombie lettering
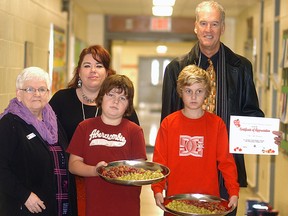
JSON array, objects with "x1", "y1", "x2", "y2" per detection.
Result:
[{"x1": 67, "y1": 117, "x2": 146, "y2": 216}]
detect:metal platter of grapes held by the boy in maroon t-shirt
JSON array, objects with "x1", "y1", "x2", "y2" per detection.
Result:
[{"x1": 96, "y1": 160, "x2": 170, "y2": 186}]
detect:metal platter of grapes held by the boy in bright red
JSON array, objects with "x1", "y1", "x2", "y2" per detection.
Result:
[{"x1": 164, "y1": 194, "x2": 235, "y2": 216}]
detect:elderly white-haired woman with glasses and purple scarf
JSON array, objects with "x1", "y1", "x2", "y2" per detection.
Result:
[{"x1": 0, "y1": 67, "x2": 76, "y2": 216}]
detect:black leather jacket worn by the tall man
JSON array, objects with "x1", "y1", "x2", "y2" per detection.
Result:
[{"x1": 161, "y1": 43, "x2": 264, "y2": 187}]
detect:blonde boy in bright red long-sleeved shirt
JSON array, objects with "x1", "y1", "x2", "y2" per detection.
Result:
[{"x1": 152, "y1": 65, "x2": 239, "y2": 214}]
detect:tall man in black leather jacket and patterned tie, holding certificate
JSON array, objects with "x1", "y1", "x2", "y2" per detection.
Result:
[{"x1": 161, "y1": 1, "x2": 281, "y2": 215}]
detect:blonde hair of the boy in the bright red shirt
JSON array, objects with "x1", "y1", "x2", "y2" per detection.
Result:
[{"x1": 177, "y1": 64, "x2": 211, "y2": 98}]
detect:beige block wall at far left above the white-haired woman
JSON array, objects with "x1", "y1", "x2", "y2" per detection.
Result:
[{"x1": 0, "y1": 0, "x2": 66, "y2": 112}]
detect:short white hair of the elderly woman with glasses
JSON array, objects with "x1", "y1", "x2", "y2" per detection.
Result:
[{"x1": 16, "y1": 67, "x2": 51, "y2": 89}]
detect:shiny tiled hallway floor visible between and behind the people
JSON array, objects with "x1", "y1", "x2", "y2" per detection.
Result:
[{"x1": 137, "y1": 107, "x2": 258, "y2": 216}]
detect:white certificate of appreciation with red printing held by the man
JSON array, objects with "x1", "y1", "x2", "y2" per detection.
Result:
[{"x1": 229, "y1": 116, "x2": 280, "y2": 155}]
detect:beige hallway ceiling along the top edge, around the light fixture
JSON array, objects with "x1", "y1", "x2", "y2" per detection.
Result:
[{"x1": 74, "y1": 0, "x2": 259, "y2": 17}]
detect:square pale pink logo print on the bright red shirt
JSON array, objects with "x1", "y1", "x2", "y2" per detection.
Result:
[{"x1": 179, "y1": 135, "x2": 204, "y2": 157}]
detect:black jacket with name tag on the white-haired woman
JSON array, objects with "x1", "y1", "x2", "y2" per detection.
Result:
[{"x1": 0, "y1": 113, "x2": 77, "y2": 216}]
